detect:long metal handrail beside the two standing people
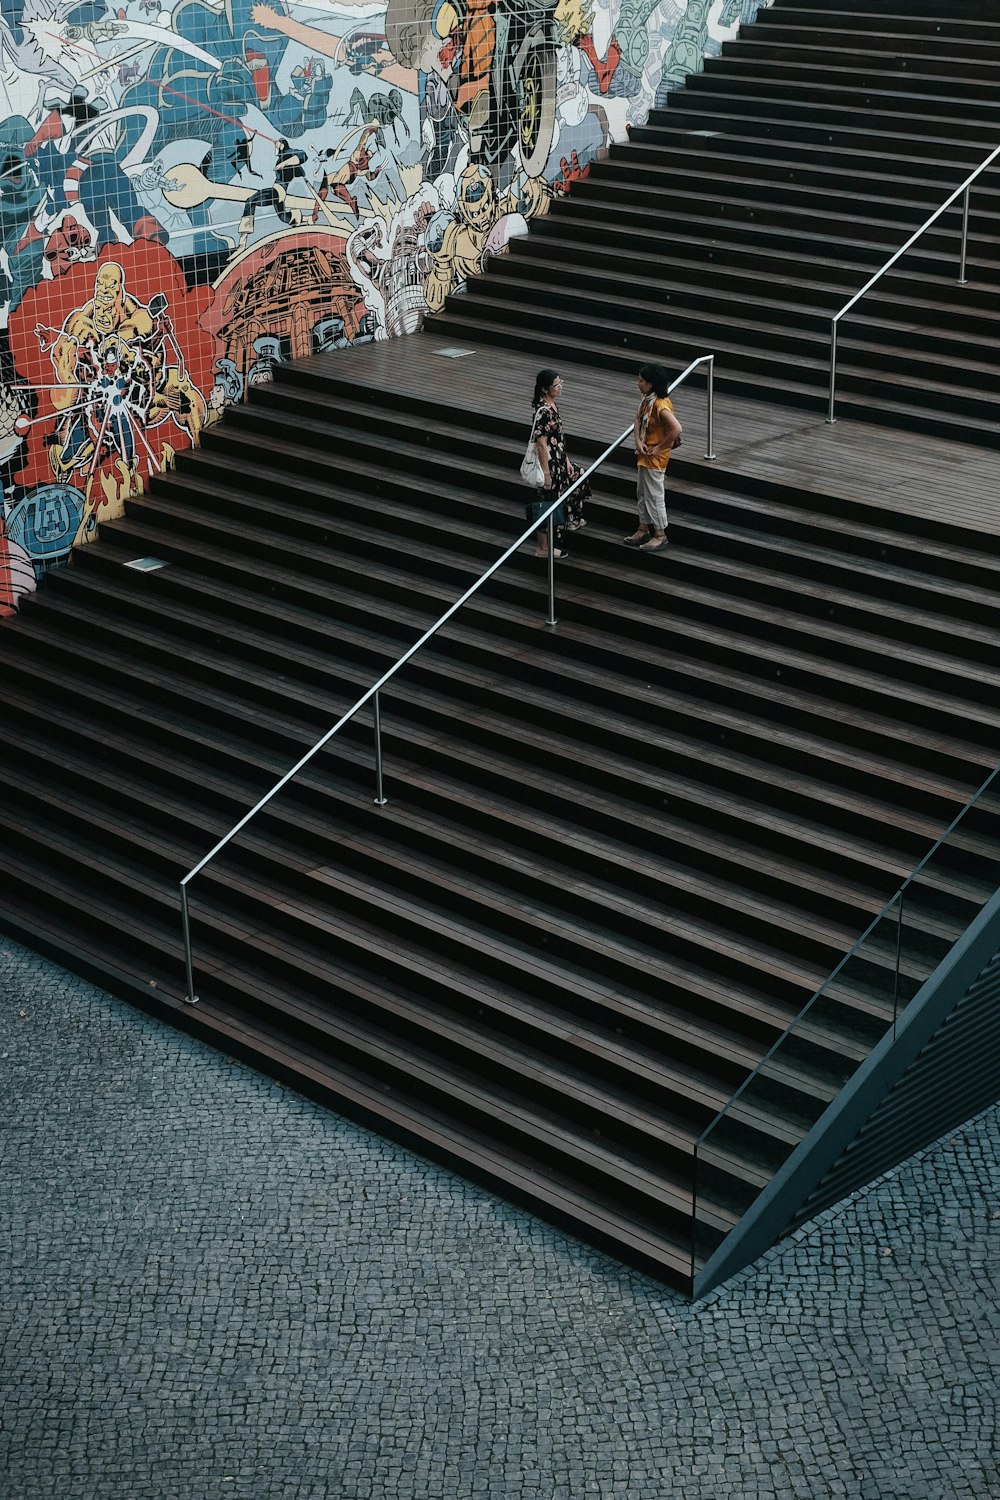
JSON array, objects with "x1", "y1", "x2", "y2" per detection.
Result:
[{"x1": 180, "y1": 354, "x2": 715, "y2": 1005}]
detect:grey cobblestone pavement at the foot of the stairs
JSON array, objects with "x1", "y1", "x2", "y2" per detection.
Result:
[{"x1": 0, "y1": 938, "x2": 1000, "y2": 1500}]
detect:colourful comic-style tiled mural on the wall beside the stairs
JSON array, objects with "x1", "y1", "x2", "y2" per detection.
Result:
[{"x1": 0, "y1": 0, "x2": 769, "y2": 612}]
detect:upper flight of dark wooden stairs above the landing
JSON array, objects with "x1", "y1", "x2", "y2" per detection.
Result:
[{"x1": 433, "y1": 0, "x2": 1000, "y2": 446}]
